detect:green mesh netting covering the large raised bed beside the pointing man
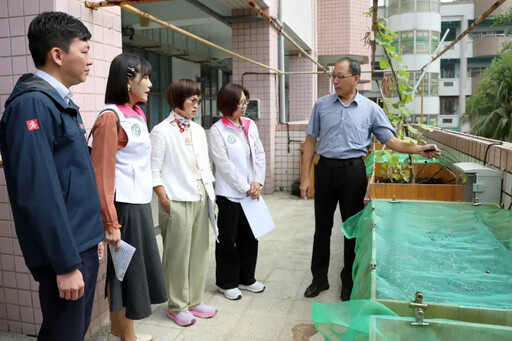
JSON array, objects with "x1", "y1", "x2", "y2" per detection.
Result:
[{"x1": 342, "y1": 200, "x2": 512, "y2": 309}]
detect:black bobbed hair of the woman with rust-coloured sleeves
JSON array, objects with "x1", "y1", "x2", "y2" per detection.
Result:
[{"x1": 105, "y1": 53, "x2": 152, "y2": 104}]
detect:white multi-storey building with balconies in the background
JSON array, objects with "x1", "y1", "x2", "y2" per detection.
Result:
[{"x1": 368, "y1": 0, "x2": 512, "y2": 132}]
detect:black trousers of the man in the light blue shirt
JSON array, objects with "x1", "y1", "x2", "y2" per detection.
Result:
[{"x1": 311, "y1": 157, "x2": 368, "y2": 290}]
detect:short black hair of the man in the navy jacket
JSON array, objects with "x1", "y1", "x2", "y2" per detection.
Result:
[{"x1": 27, "y1": 12, "x2": 91, "y2": 67}]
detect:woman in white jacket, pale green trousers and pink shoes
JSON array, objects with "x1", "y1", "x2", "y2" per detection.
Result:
[{"x1": 151, "y1": 79, "x2": 217, "y2": 326}]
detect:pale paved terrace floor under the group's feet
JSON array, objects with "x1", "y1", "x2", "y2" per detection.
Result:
[{"x1": 0, "y1": 192, "x2": 343, "y2": 341}]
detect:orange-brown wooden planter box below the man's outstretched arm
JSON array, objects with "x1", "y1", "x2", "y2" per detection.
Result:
[{"x1": 369, "y1": 163, "x2": 466, "y2": 201}]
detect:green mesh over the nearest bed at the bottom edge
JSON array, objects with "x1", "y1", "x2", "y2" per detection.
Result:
[{"x1": 311, "y1": 300, "x2": 512, "y2": 341}]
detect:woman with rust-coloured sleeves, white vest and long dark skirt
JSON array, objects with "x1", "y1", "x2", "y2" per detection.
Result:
[{"x1": 91, "y1": 53, "x2": 167, "y2": 341}]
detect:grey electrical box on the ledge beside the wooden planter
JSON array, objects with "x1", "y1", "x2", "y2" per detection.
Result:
[{"x1": 453, "y1": 162, "x2": 503, "y2": 204}]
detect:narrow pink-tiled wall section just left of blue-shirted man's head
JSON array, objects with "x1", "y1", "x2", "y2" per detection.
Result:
[{"x1": 288, "y1": 56, "x2": 317, "y2": 121}]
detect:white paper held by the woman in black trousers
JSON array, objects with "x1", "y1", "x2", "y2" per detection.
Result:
[{"x1": 240, "y1": 196, "x2": 276, "y2": 239}]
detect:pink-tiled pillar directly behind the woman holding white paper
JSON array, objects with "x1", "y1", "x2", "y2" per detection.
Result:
[{"x1": 231, "y1": 11, "x2": 278, "y2": 193}]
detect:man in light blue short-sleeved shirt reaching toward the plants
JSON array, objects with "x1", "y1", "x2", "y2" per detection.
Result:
[{"x1": 300, "y1": 57, "x2": 440, "y2": 301}]
